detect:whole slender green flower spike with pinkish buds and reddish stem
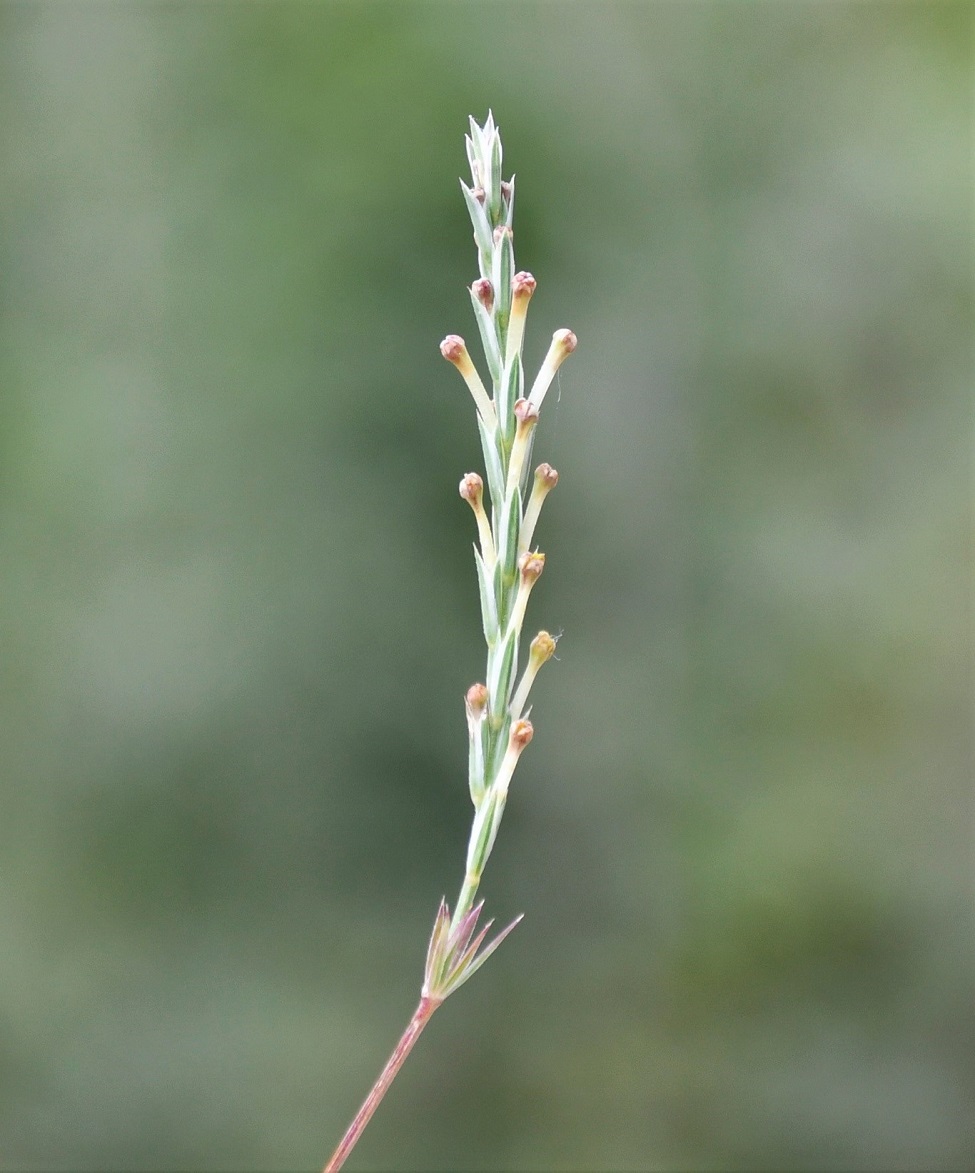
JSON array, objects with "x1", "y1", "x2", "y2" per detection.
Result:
[{"x1": 325, "y1": 113, "x2": 576, "y2": 1173}]
